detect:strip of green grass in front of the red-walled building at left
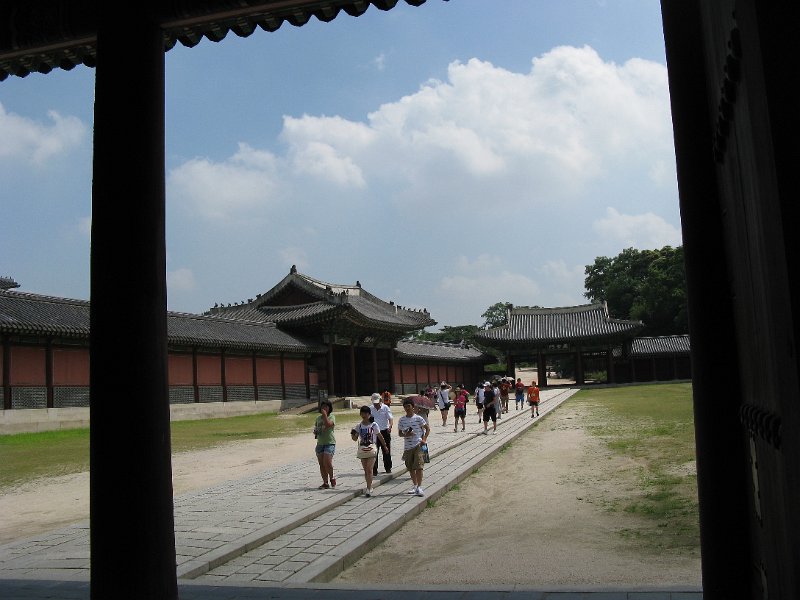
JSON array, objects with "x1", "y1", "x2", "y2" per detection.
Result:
[{"x1": 0, "y1": 411, "x2": 359, "y2": 490}]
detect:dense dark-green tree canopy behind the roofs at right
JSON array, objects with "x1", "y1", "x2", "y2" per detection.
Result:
[{"x1": 584, "y1": 246, "x2": 689, "y2": 335}]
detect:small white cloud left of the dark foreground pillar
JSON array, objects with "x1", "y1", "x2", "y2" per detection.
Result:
[{"x1": 0, "y1": 104, "x2": 86, "y2": 165}]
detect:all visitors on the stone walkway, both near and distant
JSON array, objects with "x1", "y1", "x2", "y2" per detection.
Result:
[{"x1": 314, "y1": 377, "x2": 539, "y2": 497}]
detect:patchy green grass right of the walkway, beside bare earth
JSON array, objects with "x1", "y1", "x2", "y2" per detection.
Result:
[{"x1": 570, "y1": 383, "x2": 700, "y2": 550}]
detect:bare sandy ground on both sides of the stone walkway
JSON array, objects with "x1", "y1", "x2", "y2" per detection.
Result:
[{"x1": 0, "y1": 402, "x2": 700, "y2": 586}]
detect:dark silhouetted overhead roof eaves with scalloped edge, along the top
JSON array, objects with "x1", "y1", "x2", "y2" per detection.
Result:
[{"x1": 0, "y1": 0, "x2": 432, "y2": 81}]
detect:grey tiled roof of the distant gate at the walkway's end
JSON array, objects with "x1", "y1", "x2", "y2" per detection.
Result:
[{"x1": 478, "y1": 304, "x2": 644, "y2": 345}]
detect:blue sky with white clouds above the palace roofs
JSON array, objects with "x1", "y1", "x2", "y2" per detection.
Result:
[{"x1": 0, "y1": 0, "x2": 682, "y2": 331}]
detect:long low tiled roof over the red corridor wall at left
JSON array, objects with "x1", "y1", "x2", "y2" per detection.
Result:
[{"x1": 0, "y1": 290, "x2": 326, "y2": 352}]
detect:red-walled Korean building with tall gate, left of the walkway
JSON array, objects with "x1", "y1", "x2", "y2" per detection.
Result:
[{"x1": 0, "y1": 268, "x2": 494, "y2": 410}]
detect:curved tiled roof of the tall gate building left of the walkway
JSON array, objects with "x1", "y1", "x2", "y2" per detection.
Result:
[{"x1": 206, "y1": 267, "x2": 436, "y2": 332}]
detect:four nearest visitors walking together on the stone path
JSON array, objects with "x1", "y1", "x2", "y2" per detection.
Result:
[{"x1": 314, "y1": 390, "x2": 431, "y2": 497}]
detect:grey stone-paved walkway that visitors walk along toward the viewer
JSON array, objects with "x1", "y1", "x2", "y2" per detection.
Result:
[{"x1": 0, "y1": 389, "x2": 702, "y2": 600}]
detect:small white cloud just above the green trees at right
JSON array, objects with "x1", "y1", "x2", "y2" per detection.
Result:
[{"x1": 592, "y1": 207, "x2": 682, "y2": 249}]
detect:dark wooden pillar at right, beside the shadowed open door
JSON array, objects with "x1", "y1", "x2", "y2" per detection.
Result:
[{"x1": 660, "y1": 0, "x2": 759, "y2": 600}]
